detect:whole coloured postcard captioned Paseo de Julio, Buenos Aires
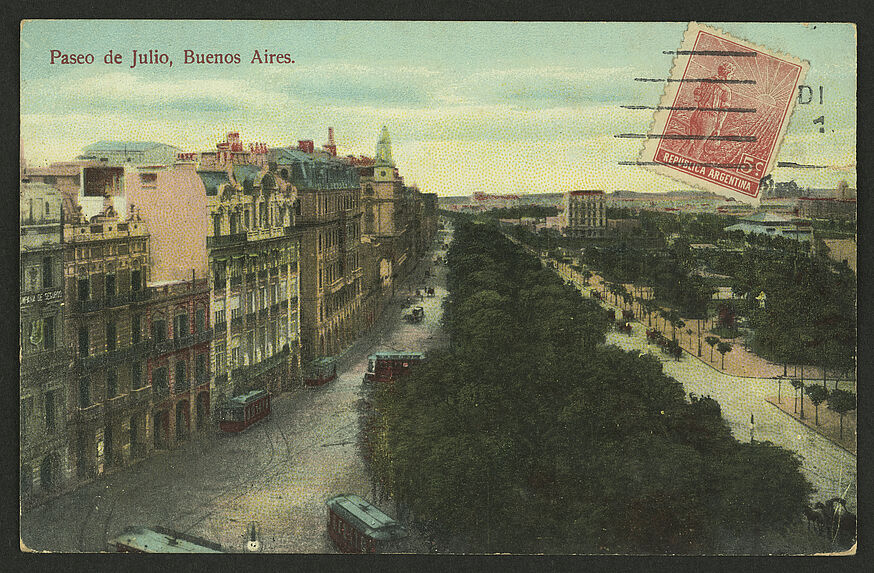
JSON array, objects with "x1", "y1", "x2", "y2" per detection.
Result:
[{"x1": 19, "y1": 20, "x2": 858, "y2": 555}]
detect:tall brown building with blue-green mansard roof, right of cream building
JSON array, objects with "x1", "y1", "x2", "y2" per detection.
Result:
[{"x1": 270, "y1": 136, "x2": 362, "y2": 361}]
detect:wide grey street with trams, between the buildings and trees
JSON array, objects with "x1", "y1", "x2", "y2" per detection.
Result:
[{"x1": 21, "y1": 230, "x2": 446, "y2": 553}]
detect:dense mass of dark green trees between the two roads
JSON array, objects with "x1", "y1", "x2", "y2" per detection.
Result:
[{"x1": 368, "y1": 220, "x2": 811, "y2": 553}]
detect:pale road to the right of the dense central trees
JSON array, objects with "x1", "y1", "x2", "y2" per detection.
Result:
[{"x1": 577, "y1": 270, "x2": 856, "y2": 513}]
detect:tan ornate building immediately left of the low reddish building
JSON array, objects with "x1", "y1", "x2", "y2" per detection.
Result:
[{"x1": 64, "y1": 197, "x2": 152, "y2": 481}]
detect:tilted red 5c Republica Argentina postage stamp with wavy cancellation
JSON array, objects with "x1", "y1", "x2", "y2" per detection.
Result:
[{"x1": 641, "y1": 22, "x2": 809, "y2": 204}]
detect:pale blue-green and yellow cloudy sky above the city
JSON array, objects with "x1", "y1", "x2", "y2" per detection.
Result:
[{"x1": 20, "y1": 20, "x2": 857, "y2": 195}]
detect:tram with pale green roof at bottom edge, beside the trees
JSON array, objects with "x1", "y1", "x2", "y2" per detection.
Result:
[{"x1": 325, "y1": 494, "x2": 410, "y2": 553}]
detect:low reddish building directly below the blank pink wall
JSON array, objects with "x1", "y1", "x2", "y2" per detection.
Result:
[{"x1": 146, "y1": 278, "x2": 212, "y2": 449}]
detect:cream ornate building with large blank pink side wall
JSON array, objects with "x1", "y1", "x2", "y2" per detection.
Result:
[{"x1": 127, "y1": 133, "x2": 300, "y2": 408}]
